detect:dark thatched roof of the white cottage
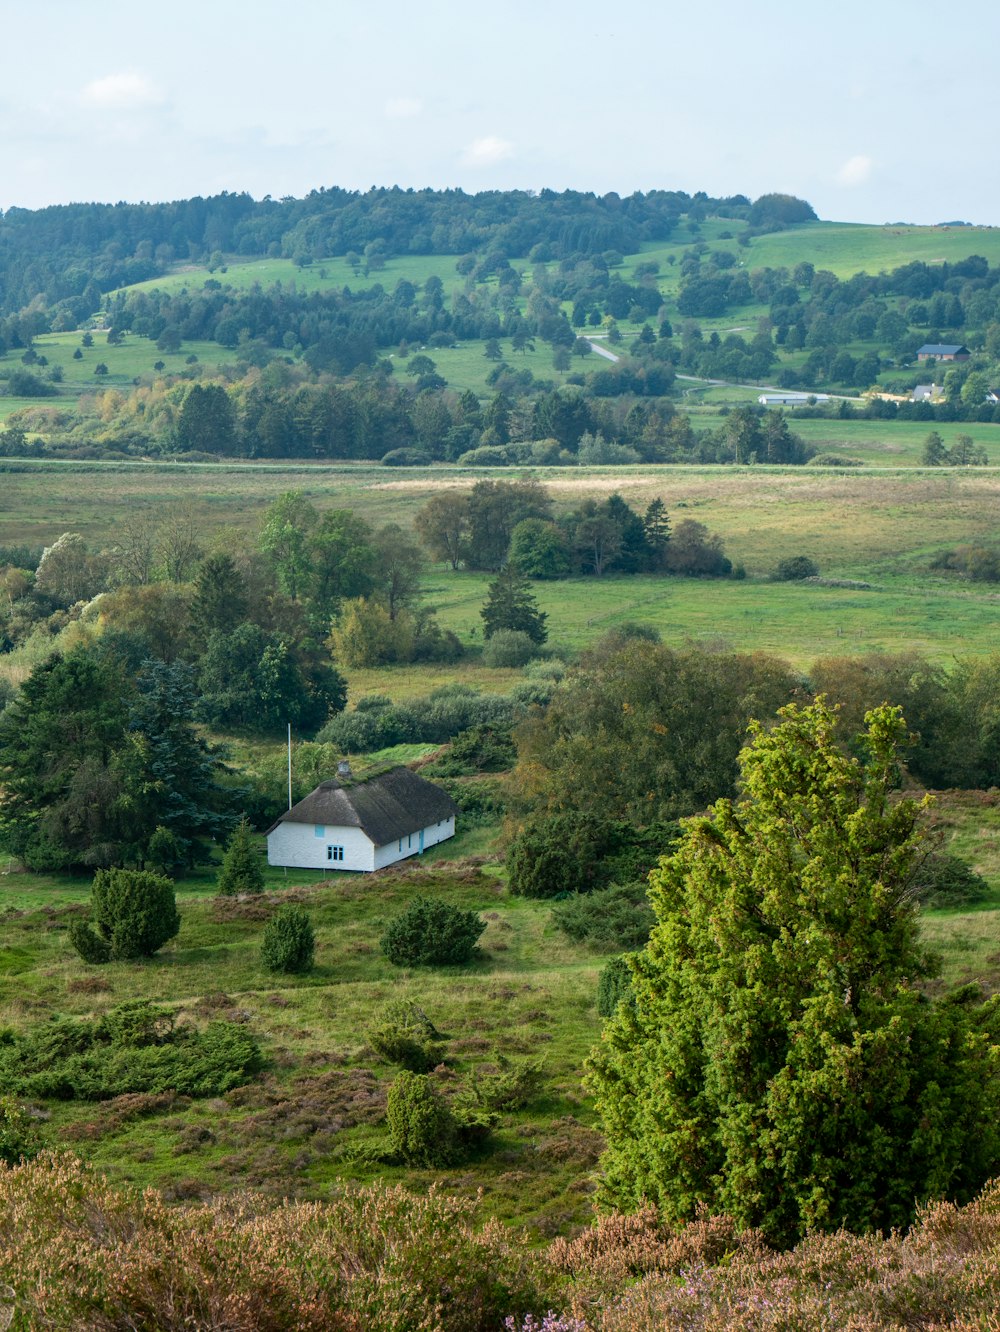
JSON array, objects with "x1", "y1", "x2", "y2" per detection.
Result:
[{"x1": 268, "y1": 767, "x2": 458, "y2": 846}]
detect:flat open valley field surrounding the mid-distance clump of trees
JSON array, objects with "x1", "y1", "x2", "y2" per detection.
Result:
[{"x1": 1, "y1": 466, "x2": 1000, "y2": 694}]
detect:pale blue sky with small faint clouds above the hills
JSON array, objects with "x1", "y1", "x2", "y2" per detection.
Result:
[{"x1": 0, "y1": 0, "x2": 1000, "y2": 225}]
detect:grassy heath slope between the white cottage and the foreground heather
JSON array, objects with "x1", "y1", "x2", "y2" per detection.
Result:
[{"x1": 0, "y1": 797, "x2": 1000, "y2": 1235}]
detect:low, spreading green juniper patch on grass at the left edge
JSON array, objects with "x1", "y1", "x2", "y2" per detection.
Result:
[{"x1": 0, "y1": 999, "x2": 264, "y2": 1100}]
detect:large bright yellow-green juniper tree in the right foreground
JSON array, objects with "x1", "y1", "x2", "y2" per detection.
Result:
[{"x1": 590, "y1": 702, "x2": 1000, "y2": 1243}]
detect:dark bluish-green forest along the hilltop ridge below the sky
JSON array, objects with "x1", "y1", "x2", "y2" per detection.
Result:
[{"x1": 0, "y1": 186, "x2": 816, "y2": 318}]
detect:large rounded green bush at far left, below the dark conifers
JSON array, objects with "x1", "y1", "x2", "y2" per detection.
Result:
[{"x1": 69, "y1": 870, "x2": 181, "y2": 963}]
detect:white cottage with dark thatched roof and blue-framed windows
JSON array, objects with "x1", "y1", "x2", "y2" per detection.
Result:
[{"x1": 268, "y1": 763, "x2": 458, "y2": 870}]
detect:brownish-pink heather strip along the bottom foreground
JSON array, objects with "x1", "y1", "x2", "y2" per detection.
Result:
[{"x1": 0, "y1": 1154, "x2": 1000, "y2": 1332}]
